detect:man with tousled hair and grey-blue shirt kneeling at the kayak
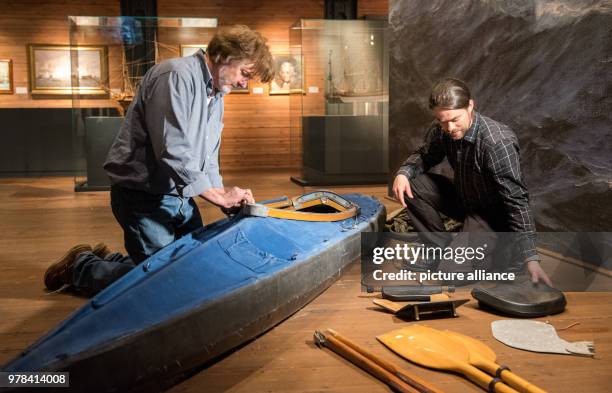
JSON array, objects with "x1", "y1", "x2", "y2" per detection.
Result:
[{"x1": 44, "y1": 26, "x2": 274, "y2": 293}]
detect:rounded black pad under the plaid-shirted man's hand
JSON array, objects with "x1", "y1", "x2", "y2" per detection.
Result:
[{"x1": 472, "y1": 280, "x2": 567, "y2": 318}]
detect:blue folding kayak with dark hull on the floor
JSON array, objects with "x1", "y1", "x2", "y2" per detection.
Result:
[{"x1": 3, "y1": 194, "x2": 385, "y2": 392}]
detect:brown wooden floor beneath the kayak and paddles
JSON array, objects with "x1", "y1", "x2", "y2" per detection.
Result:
[{"x1": 0, "y1": 171, "x2": 612, "y2": 393}]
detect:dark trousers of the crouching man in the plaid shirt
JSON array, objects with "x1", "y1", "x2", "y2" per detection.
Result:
[{"x1": 404, "y1": 173, "x2": 510, "y2": 273}]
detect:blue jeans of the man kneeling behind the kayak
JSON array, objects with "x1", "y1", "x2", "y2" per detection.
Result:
[{"x1": 73, "y1": 186, "x2": 203, "y2": 293}]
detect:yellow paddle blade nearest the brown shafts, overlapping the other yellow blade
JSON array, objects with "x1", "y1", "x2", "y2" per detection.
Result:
[{"x1": 376, "y1": 325, "x2": 469, "y2": 373}]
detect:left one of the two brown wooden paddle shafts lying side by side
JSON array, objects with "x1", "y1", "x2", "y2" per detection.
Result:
[{"x1": 315, "y1": 332, "x2": 420, "y2": 393}]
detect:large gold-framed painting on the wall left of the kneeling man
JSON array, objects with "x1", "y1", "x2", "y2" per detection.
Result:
[{"x1": 28, "y1": 44, "x2": 109, "y2": 96}]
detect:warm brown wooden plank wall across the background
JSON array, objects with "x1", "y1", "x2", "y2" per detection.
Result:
[{"x1": 0, "y1": 0, "x2": 388, "y2": 170}]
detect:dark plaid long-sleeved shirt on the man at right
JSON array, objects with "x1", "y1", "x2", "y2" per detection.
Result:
[{"x1": 397, "y1": 111, "x2": 539, "y2": 260}]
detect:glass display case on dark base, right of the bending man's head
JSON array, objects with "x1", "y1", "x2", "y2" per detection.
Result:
[{"x1": 289, "y1": 19, "x2": 389, "y2": 186}]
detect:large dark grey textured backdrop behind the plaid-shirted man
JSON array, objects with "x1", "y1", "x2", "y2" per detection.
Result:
[{"x1": 389, "y1": 0, "x2": 612, "y2": 232}]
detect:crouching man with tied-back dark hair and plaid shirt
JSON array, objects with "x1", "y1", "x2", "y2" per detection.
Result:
[{"x1": 393, "y1": 78, "x2": 551, "y2": 285}]
